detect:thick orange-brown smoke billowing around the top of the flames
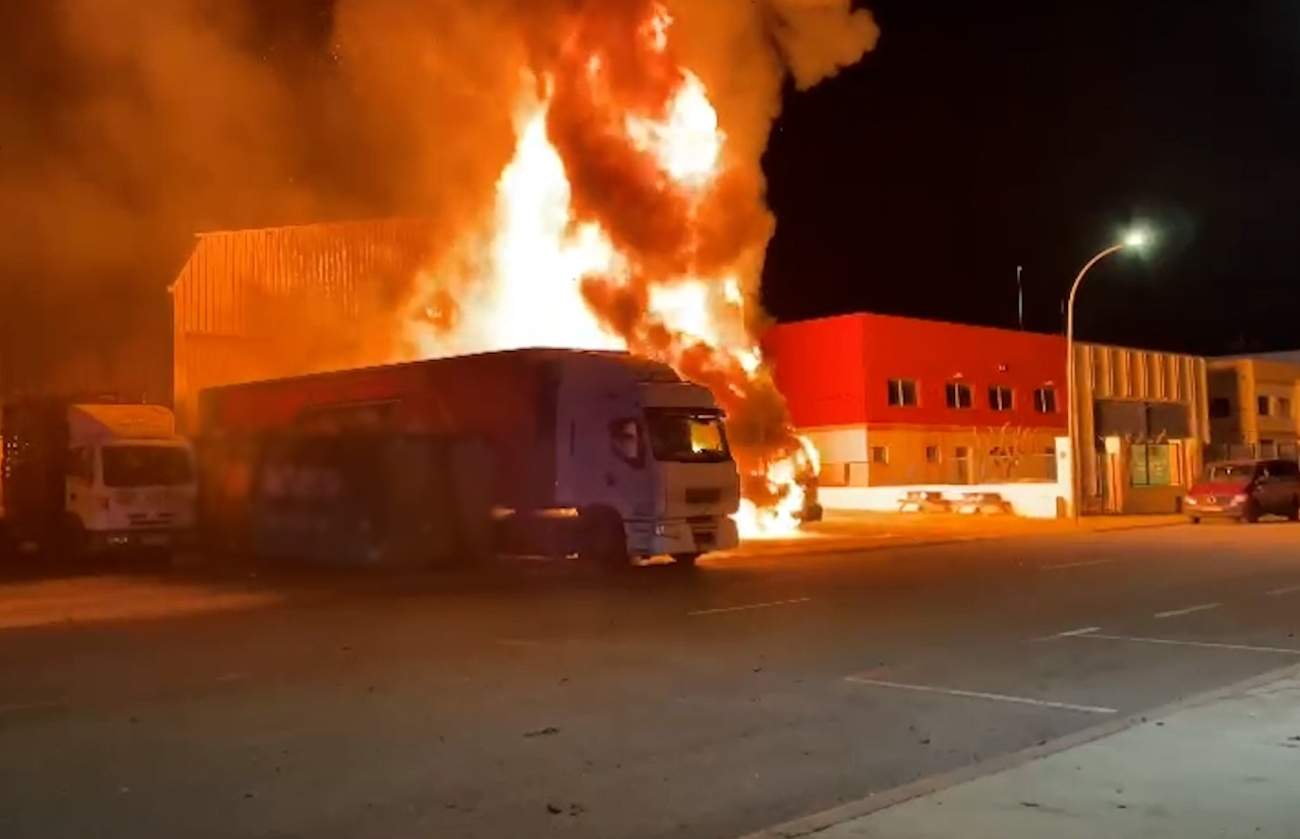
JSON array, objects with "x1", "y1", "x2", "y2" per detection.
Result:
[{"x1": 0, "y1": 0, "x2": 876, "y2": 398}]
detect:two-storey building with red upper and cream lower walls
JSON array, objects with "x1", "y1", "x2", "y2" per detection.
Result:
[{"x1": 764, "y1": 313, "x2": 1069, "y2": 486}]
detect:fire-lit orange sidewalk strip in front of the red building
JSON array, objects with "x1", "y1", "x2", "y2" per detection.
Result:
[{"x1": 740, "y1": 511, "x2": 1187, "y2": 554}]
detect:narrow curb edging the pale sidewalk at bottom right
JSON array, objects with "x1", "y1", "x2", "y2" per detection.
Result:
[{"x1": 740, "y1": 662, "x2": 1300, "y2": 839}]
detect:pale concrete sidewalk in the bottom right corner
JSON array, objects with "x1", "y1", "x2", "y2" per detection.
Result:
[{"x1": 759, "y1": 667, "x2": 1300, "y2": 839}]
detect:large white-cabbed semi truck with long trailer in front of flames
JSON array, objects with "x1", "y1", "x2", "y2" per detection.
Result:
[{"x1": 199, "y1": 349, "x2": 740, "y2": 565}]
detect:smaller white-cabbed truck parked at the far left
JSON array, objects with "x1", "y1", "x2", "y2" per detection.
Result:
[{"x1": 0, "y1": 398, "x2": 198, "y2": 555}]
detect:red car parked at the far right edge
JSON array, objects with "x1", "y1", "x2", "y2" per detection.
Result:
[{"x1": 1183, "y1": 460, "x2": 1300, "y2": 524}]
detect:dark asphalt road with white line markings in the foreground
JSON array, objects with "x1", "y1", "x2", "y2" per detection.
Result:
[{"x1": 0, "y1": 523, "x2": 1300, "y2": 839}]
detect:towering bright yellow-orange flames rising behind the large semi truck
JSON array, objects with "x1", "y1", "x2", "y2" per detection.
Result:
[{"x1": 407, "y1": 5, "x2": 816, "y2": 537}]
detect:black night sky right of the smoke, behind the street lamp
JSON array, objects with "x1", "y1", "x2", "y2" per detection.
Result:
[{"x1": 764, "y1": 0, "x2": 1300, "y2": 354}]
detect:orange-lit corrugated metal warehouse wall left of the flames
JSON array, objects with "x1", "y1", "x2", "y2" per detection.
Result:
[{"x1": 170, "y1": 219, "x2": 432, "y2": 431}]
